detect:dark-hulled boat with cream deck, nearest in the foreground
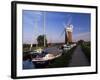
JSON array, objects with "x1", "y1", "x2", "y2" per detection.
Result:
[{"x1": 28, "y1": 48, "x2": 62, "y2": 68}]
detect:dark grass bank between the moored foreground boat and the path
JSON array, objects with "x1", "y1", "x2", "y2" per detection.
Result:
[{"x1": 47, "y1": 47, "x2": 76, "y2": 68}]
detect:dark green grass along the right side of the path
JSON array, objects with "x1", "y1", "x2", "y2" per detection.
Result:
[{"x1": 81, "y1": 44, "x2": 91, "y2": 62}]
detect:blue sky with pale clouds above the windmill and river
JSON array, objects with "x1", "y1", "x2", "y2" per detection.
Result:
[{"x1": 22, "y1": 10, "x2": 91, "y2": 44}]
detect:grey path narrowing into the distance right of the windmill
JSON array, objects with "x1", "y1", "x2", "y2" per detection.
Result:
[{"x1": 69, "y1": 46, "x2": 89, "y2": 67}]
